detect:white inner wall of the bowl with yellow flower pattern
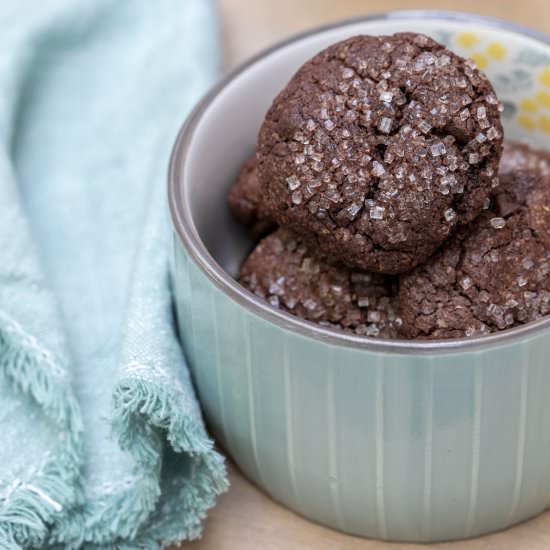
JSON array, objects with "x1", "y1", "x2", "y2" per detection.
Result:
[{"x1": 176, "y1": 14, "x2": 550, "y2": 276}]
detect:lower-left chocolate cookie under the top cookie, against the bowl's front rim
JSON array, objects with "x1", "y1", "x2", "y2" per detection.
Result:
[{"x1": 239, "y1": 228, "x2": 401, "y2": 338}]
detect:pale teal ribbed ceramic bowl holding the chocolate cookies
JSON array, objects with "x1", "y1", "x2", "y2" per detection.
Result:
[{"x1": 170, "y1": 12, "x2": 550, "y2": 541}]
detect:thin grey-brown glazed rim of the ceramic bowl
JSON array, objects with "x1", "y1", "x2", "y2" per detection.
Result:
[{"x1": 168, "y1": 10, "x2": 550, "y2": 355}]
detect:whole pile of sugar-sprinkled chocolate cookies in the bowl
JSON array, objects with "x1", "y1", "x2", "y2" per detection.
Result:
[{"x1": 229, "y1": 33, "x2": 550, "y2": 339}]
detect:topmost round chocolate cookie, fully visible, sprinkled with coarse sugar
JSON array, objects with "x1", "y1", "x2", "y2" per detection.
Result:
[{"x1": 258, "y1": 33, "x2": 502, "y2": 273}]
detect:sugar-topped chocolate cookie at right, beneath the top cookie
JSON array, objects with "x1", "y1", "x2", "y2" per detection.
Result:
[{"x1": 399, "y1": 170, "x2": 550, "y2": 339}]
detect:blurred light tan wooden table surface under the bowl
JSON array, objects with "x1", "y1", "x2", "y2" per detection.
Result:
[{"x1": 180, "y1": 0, "x2": 550, "y2": 550}]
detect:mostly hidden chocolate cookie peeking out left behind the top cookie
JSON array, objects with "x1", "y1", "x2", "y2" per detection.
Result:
[{"x1": 228, "y1": 155, "x2": 275, "y2": 236}]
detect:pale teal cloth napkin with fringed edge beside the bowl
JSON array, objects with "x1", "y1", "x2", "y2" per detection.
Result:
[{"x1": 0, "y1": 0, "x2": 227, "y2": 549}]
